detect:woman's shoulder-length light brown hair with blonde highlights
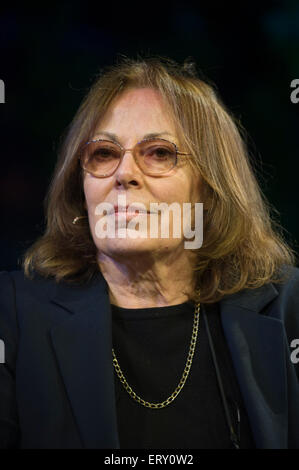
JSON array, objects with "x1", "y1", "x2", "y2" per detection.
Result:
[{"x1": 22, "y1": 58, "x2": 296, "y2": 303}]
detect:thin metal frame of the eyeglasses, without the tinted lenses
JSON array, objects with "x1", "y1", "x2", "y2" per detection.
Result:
[{"x1": 79, "y1": 137, "x2": 191, "y2": 178}]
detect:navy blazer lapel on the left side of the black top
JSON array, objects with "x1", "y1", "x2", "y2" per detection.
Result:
[{"x1": 50, "y1": 273, "x2": 119, "y2": 449}]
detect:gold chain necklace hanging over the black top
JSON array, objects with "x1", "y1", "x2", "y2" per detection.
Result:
[{"x1": 112, "y1": 303, "x2": 200, "y2": 408}]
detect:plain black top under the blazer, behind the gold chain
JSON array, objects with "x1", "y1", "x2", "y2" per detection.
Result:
[{"x1": 112, "y1": 302, "x2": 255, "y2": 449}]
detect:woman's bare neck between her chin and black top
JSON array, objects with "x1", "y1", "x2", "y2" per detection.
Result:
[{"x1": 98, "y1": 248, "x2": 195, "y2": 308}]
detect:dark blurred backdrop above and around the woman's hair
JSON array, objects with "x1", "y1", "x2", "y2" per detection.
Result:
[{"x1": 0, "y1": 0, "x2": 299, "y2": 270}]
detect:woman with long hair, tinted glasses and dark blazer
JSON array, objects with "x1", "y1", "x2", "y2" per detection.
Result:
[{"x1": 0, "y1": 59, "x2": 299, "y2": 449}]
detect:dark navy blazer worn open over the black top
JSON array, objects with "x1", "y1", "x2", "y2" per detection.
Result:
[{"x1": 0, "y1": 268, "x2": 299, "y2": 449}]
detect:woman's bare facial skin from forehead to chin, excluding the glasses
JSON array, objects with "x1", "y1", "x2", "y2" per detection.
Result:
[{"x1": 84, "y1": 88, "x2": 201, "y2": 257}]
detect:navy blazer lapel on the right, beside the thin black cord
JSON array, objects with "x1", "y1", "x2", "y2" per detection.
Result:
[{"x1": 220, "y1": 284, "x2": 288, "y2": 448}]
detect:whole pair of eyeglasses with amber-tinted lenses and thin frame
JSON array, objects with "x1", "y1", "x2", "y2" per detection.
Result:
[{"x1": 80, "y1": 138, "x2": 190, "y2": 178}]
